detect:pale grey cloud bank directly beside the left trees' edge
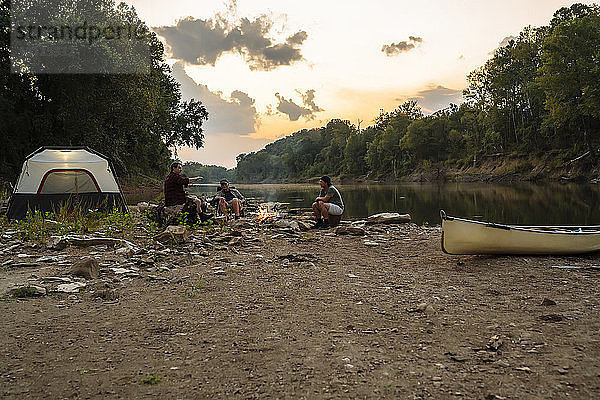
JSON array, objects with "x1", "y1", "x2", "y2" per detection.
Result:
[{"x1": 173, "y1": 62, "x2": 258, "y2": 136}]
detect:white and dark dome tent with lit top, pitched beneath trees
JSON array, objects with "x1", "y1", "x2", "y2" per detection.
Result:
[{"x1": 8, "y1": 147, "x2": 127, "y2": 219}]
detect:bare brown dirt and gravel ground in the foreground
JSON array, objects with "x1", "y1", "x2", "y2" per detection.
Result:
[{"x1": 0, "y1": 220, "x2": 600, "y2": 399}]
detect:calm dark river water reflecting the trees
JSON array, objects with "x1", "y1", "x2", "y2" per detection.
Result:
[{"x1": 185, "y1": 183, "x2": 600, "y2": 225}]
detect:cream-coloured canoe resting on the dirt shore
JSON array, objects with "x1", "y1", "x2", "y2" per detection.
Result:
[{"x1": 440, "y1": 210, "x2": 600, "y2": 254}]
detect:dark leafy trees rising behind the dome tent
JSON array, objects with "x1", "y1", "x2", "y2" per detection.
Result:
[{"x1": 0, "y1": 0, "x2": 208, "y2": 182}]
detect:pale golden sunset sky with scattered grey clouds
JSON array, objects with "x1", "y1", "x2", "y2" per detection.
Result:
[{"x1": 125, "y1": 0, "x2": 592, "y2": 168}]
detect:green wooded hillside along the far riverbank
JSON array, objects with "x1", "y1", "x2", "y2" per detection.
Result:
[{"x1": 237, "y1": 3, "x2": 600, "y2": 182}]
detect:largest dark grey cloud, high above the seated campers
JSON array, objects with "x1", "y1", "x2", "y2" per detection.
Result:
[{"x1": 153, "y1": 11, "x2": 308, "y2": 71}]
